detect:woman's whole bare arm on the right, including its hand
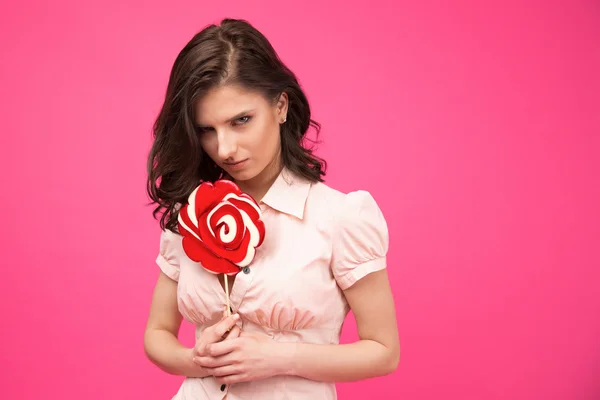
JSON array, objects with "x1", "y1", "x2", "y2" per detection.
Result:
[{"x1": 198, "y1": 270, "x2": 400, "y2": 384}]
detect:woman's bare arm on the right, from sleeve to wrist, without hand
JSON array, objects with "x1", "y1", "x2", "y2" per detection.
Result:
[{"x1": 280, "y1": 270, "x2": 400, "y2": 382}]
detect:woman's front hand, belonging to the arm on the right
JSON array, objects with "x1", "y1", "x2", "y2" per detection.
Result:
[{"x1": 196, "y1": 332, "x2": 293, "y2": 385}]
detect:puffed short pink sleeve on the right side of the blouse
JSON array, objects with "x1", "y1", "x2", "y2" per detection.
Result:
[{"x1": 331, "y1": 190, "x2": 389, "y2": 290}]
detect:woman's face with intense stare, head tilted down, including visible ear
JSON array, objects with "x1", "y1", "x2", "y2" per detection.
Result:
[{"x1": 195, "y1": 85, "x2": 288, "y2": 181}]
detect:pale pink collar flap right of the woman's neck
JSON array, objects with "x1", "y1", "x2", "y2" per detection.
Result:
[{"x1": 260, "y1": 167, "x2": 311, "y2": 219}]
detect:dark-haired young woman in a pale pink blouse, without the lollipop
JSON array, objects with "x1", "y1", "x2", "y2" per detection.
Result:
[{"x1": 144, "y1": 19, "x2": 400, "y2": 400}]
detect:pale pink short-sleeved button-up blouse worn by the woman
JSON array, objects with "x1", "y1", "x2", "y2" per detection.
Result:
[{"x1": 156, "y1": 169, "x2": 388, "y2": 400}]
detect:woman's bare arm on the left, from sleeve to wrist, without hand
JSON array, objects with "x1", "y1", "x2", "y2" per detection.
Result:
[{"x1": 144, "y1": 272, "x2": 208, "y2": 377}]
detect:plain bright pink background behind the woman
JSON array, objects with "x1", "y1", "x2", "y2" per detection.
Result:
[{"x1": 0, "y1": 0, "x2": 600, "y2": 400}]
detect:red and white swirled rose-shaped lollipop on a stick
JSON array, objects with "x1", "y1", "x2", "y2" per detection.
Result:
[{"x1": 178, "y1": 179, "x2": 265, "y2": 314}]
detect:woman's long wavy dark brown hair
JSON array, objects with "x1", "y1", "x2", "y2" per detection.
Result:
[{"x1": 147, "y1": 19, "x2": 327, "y2": 231}]
